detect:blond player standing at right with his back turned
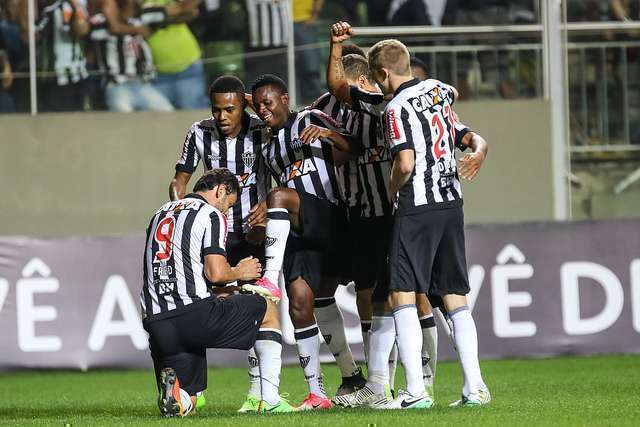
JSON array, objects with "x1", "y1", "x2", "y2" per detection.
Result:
[{"x1": 368, "y1": 40, "x2": 491, "y2": 409}]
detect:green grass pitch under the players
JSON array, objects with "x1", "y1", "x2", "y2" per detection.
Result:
[{"x1": 0, "y1": 356, "x2": 640, "y2": 427}]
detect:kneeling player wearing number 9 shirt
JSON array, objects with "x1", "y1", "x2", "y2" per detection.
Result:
[{"x1": 140, "y1": 169, "x2": 292, "y2": 417}]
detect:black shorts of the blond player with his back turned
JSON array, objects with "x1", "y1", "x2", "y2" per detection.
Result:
[{"x1": 389, "y1": 206, "x2": 469, "y2": 296}]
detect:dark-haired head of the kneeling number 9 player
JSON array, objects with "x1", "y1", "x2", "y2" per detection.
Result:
[{"x1": 193, "y1": 168, "x2": 240, "y2": 215}]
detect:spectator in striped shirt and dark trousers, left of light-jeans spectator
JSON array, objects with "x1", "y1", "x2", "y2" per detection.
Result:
[{"x1": 20, "y1": 0, "x2": 89, "y2": 112}]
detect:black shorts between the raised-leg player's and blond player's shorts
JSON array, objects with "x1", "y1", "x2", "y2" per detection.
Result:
[{"x1": 352, "y1": 216, "x2": 393, "y2": 302}]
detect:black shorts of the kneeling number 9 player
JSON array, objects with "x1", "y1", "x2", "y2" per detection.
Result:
[{"x1": 143, "y1": 295, "x2": 267, "y2": 395}]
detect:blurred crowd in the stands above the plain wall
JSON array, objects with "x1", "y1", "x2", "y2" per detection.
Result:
[{"x1": 0, "y1": 0, "x2": 640, "y2": 113}]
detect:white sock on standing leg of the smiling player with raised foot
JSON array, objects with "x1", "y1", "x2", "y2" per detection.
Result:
[{"x1": 293, "y1": 324, "x2": 327, "y2": 398}]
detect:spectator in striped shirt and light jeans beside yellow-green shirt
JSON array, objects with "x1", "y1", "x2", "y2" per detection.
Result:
[{"x1": 91, "y1": 0, "x2": 173, "y2": 112}]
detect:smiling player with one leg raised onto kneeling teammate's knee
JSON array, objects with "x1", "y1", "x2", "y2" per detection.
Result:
[{"x1": 251, "y1": 74, "x2": 351, "y2": 410}]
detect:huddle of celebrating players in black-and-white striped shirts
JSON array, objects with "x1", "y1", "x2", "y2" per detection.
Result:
[{"x1": 141, "y1": 22, "x2": 491, "y2": 416}]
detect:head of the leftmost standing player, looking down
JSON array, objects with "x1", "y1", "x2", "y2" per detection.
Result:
[{"x1": 209, "y1": 76, "x2": 246, "y2": 138}]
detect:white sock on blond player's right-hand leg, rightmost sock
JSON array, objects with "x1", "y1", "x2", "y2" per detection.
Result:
[{"x1": 449, "y1": 305, "x2": 486, "y2": 396}]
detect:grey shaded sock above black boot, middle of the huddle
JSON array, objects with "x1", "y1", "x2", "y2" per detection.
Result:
[{"x1": 314, "y1": 297, "x2": 358, "y2": 378}]
